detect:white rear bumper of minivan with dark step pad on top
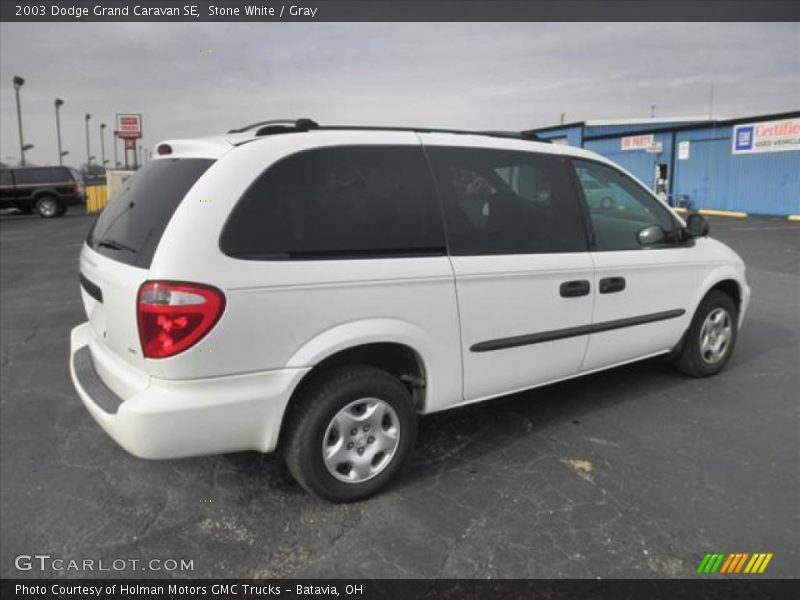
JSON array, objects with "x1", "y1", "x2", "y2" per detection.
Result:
[{"x1": 70, "y1": 323, "x2": 308, "y2": 459}]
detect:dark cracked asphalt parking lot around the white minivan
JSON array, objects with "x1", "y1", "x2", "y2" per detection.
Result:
[{"x1": 0, "y1": 210, "x2": 800, "y2": 578}]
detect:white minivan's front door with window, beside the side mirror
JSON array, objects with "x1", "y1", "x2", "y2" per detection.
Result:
[{"x1": 572, "y1": 159, "x2": 704, "y2": 371}]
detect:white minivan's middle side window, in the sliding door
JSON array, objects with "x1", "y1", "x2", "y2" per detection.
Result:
[{"x1": 426, "y1": 146, "x2": 587, "y2": 255}]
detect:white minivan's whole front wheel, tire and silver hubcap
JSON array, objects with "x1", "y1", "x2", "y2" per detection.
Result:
[{"x1": 675, "y1": 290, "x2": 738, "y2": 377}]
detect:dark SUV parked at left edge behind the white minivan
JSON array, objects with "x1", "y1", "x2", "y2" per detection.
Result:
[{"x1": 0, "y1": 167, "x2": 84, "y2": 219}]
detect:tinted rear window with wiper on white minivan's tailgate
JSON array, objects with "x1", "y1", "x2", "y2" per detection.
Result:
[{"x1": 86, "y1": 158, "x2": 214, "y2": 268}]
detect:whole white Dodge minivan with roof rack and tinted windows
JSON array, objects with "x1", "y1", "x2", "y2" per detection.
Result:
[{"x1": 70, "y1": 119, "x2": 750, "y2": 501}]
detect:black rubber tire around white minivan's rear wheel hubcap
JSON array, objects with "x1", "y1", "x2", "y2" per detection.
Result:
[{"x1": 281, "y1": 365, "x2": 417, "y2": 502}]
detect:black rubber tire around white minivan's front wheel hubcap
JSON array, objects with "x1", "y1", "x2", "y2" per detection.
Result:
[{"x1": 673, "y1": 290, "x2": 739, "y2": 377}]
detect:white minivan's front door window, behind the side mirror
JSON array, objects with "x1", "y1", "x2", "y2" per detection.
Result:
[{"x1": 573, "y1": 160, "x2": 676, "y2": 251}]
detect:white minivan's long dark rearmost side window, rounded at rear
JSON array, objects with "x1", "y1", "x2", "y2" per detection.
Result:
[{"x1": 220, "y1": 146, "x2": 446, "y2": 260}]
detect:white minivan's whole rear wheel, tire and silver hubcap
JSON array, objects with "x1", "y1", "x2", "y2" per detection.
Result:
[{"x1": 282, "y1": 365, "x2": 417, "y2": 502}]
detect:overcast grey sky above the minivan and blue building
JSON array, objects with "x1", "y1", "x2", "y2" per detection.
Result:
[{"x1": 0, "y1": 23, "x2": 800, "y2": 165}]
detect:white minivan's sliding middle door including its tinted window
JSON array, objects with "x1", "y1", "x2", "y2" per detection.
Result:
[{"x1": 421, "y1": 134, "x2": 593, "y2": 402}]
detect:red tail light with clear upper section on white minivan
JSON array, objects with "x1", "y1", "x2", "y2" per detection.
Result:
[{"x1": 136, "y1": 281, "x2": 225, "y2": 358}]
